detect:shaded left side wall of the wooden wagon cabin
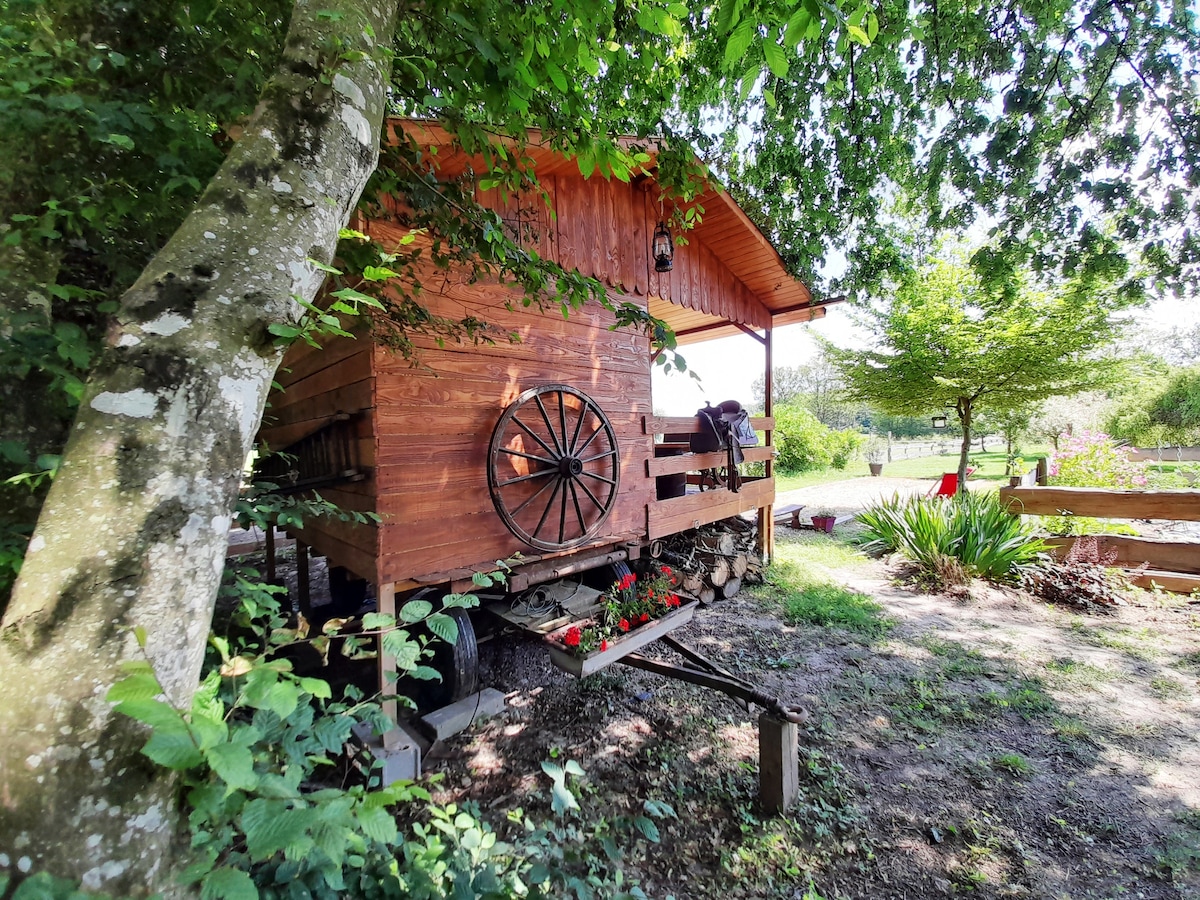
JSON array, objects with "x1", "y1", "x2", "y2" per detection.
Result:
[{"x1": 259, "y1": 338, "x2": 378, "y2": 581}]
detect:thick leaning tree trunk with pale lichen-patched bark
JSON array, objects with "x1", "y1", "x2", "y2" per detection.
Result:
[{"x1": 0, "y1": 0, "x2": 396, "y2": 895}]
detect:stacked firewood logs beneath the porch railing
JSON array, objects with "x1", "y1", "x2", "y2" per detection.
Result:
[{"x1": 650, "y1": 516, "x2": 762, "y2": 604}]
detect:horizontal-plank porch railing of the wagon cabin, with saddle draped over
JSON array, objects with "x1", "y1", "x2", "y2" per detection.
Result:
[{"x1": 642, "y1": 415, "x2": 775, "y2": 548}]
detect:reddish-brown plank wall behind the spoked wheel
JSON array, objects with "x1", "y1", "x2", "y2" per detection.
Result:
[{"x1": 374, "y1": 247, "x2": 654, "y2": 582}]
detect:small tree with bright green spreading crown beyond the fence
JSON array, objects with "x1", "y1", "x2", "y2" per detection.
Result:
[{"x1": 827, "y1": 256, "x2": 1122, "y2": 491}]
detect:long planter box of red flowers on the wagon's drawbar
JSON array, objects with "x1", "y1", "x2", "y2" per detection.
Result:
[{"x1": 546, "y1": 565, "x2": 696, "y2": 676}]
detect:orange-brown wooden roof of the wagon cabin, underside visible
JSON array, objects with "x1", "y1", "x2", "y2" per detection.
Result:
[{"x1": 391, "y1": 119, "x2": 842, "y2": 343}]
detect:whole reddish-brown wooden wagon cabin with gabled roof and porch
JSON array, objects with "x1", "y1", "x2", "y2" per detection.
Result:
[{"x1": 260, "y1": 121, "x2": 840, "y2": 710}]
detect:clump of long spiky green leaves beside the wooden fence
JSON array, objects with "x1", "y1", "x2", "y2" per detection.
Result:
[{"x1": 859, "y1": 493, "x2": 1048, "y2": 584}]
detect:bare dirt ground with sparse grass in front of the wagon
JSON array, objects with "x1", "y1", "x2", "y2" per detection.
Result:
[{"x1": 426, "y1": 525, "x2": 1200, "y2": 900}]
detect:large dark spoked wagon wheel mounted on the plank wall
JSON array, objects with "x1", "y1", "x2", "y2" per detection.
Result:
[{"x1": 487, "y1": 384, "x2": 620, "y2": 550}]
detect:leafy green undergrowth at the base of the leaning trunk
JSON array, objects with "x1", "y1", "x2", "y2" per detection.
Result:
[{"x1": 105, "y1": 549, "x2": 674, "y2": 900}]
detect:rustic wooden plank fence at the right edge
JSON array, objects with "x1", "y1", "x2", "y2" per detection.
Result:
[{"x1": 1000, "y1": 486, "x2": 1200, "y2": 594}]
